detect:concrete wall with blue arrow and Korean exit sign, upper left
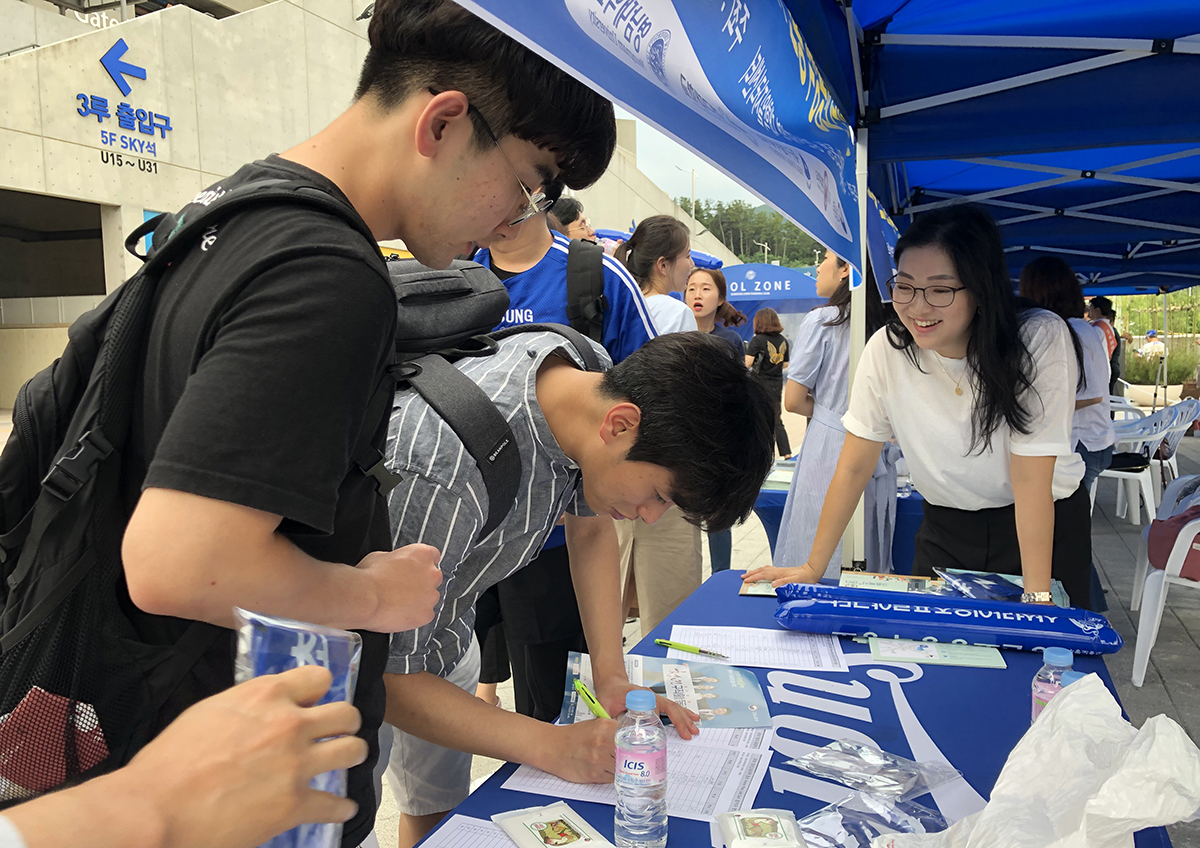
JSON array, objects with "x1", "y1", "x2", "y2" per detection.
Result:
[{"x1": 0, "y1": 0, "x2": 367, "y2": 408}]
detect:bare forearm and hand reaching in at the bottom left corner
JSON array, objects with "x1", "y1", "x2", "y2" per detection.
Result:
[{"x1": 0, "y1": 666, "x2": 367, "y2": 848}]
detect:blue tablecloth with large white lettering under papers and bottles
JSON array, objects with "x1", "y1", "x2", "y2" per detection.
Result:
[{"x1": 417, "y1": 571, "x2": 1170, "y2": 848}]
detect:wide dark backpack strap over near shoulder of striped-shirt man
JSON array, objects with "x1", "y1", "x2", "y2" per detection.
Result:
[{"x1": 398, "y1": 354, "x2": 521, "y2": 539}]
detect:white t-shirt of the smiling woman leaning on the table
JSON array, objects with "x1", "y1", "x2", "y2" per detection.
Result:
[{"x1": 841, "y1": 309, "x2": 1084, "y2": 511}]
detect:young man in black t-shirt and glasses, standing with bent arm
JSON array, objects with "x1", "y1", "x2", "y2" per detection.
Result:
[{"x1": 115, "y1": 0, "x2": 616, "y2": 847}]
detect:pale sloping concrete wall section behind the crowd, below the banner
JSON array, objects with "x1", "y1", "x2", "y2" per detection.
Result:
[{"x1": 575, "y1": 120, "x2": 742, "y2": 265}]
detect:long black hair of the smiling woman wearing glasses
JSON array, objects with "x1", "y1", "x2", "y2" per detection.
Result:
[{"x1": 888, "y1": 205, "x2": 1036, "y2": 453}]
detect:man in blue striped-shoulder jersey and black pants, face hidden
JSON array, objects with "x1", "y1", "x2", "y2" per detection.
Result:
[{"x1": 475, "y1": 211, "x2": 658, "y2": 721}]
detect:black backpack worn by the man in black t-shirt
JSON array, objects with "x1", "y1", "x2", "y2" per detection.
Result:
[{"x1": 0, "y1": 180, "x2": 385, "y2": 806}]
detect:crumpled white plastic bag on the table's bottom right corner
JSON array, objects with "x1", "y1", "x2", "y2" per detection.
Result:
[{"x1": 873, "y1": 674, "x2": 1200, "y2": 848}]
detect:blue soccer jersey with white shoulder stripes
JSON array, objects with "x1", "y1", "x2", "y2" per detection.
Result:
[{"x1": 474, "y1": 233, "x2": 659, "y2": 362}]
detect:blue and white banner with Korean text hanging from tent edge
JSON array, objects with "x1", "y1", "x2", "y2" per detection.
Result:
[{"x1": 462, "y1": 0, "x2": 860, "y2": 261}]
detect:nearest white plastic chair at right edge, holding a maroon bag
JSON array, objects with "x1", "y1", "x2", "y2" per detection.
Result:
[{"x1": 1130, "y1": 475, "x2": 1200, "y2": 687}]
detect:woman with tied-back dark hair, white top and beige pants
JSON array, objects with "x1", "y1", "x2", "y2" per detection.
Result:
[{"x1": 616, "y1": 215, "x2": 704, "y2": 633}]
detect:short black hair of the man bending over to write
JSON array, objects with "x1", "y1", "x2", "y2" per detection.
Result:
[{"x1": 600, "y1": 332, "x2": 775, "y2": 531}]
